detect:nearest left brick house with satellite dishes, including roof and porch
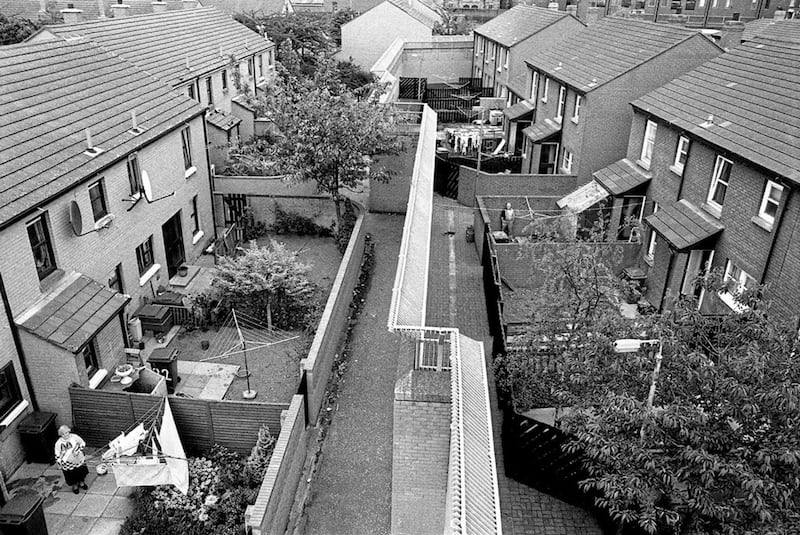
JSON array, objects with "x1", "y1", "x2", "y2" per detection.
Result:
[{"x1": 0, "y1": 41, "x2": 215, "y2": 440}]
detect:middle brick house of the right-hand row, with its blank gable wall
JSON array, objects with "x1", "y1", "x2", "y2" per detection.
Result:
[{"x1": 522, "y1": 18, "x2": 721, "y2": 185}]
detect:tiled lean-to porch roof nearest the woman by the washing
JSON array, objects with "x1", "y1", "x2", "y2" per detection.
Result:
[{"x1": 16, "y1": 273, "x2": 131, "y2": 353}]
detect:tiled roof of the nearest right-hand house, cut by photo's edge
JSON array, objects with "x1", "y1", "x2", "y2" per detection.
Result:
[{"x1": 633, "y1": 39, "x2": 800, "y2": 183}]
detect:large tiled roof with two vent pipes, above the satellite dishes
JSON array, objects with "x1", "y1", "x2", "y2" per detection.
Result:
[{"x1": 0, "y1": 41, "x2": 203, "y2": 226}]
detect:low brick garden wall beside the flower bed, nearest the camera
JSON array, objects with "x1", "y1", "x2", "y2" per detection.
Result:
[{"x1": 245, "y1": 395, "x2": 306, "y2": 535}]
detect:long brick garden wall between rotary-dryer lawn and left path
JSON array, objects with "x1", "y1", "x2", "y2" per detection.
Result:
[{"x1": 300, "y1": 209, "x2": 366, "y2": 422}]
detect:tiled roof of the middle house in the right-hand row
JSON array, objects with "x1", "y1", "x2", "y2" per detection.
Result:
[{"x1": 526, "y1": 17, "x2": 710, "y2": 92}]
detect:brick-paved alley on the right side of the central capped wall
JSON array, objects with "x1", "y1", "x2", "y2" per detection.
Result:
[{"x1": 427, "y1": 196, "x2": 602, "y2": 535}]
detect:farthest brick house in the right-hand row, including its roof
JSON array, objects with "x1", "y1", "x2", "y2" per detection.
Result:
[{"x1": 472, "y1": 5, "x2": 585, "y2": 152}]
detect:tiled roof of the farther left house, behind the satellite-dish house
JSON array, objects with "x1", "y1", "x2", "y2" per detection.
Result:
[{"x1": 41, "y1": 8, "x2": 274, "y2": 86}]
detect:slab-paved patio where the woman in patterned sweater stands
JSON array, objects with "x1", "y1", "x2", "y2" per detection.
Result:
[{"x1": 7, "y1": 458, "x2": 134, "y2": 535}]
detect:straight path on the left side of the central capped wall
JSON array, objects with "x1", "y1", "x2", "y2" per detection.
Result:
[{"x1": 305, "y1": 214, "x2": 403, "y2": 535}]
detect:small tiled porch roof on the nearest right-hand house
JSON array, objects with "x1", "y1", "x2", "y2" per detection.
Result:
[{"x1": 645, "y1": 199, "x2": 725, "y2": 251}]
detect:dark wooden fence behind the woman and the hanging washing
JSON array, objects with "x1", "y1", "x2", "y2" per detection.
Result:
[{"x1": 69, "y1": 387, "x2": 289, "y2": 454}]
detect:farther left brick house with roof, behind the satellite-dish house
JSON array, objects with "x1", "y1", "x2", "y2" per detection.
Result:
[{"x1": 29, "y1": 8, "x2": 275, "y2": 165}]
